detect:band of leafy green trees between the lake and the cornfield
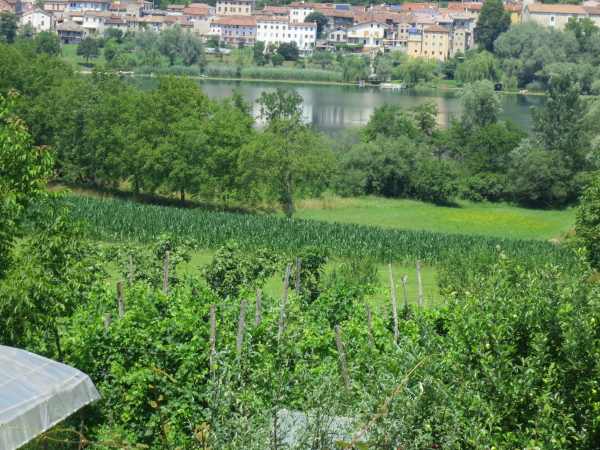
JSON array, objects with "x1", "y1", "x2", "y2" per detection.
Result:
[{"x1": 0, "y1": 38, "x2": 598, "y2": 209}]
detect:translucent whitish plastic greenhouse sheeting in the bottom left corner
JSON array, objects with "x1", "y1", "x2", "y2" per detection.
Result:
[{"x1": 0, "y1": 345, "x2": 100, "y2": 450}]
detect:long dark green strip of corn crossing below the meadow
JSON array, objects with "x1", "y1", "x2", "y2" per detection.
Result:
[{"x1": 67, "y1": 196, "x2": 573, "y2": 265}]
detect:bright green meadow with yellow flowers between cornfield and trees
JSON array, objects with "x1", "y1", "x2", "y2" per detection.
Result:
[{"x1": 297, "y1": 197, "x2": 575, "y2": 240}]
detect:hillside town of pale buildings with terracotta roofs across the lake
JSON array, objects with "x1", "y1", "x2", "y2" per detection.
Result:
[{"x1": 0, "y1": 0, "x2": 600, "y2": 61}]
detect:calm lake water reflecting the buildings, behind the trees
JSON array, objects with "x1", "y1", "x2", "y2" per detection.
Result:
[{"x1": 136, "y1": 79, "x2": 544, "y2": 133}]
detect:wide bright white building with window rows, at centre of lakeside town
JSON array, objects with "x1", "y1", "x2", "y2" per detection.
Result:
[{"x1": 256, "y1": 16, "x2": 317, "y2": 53}]
